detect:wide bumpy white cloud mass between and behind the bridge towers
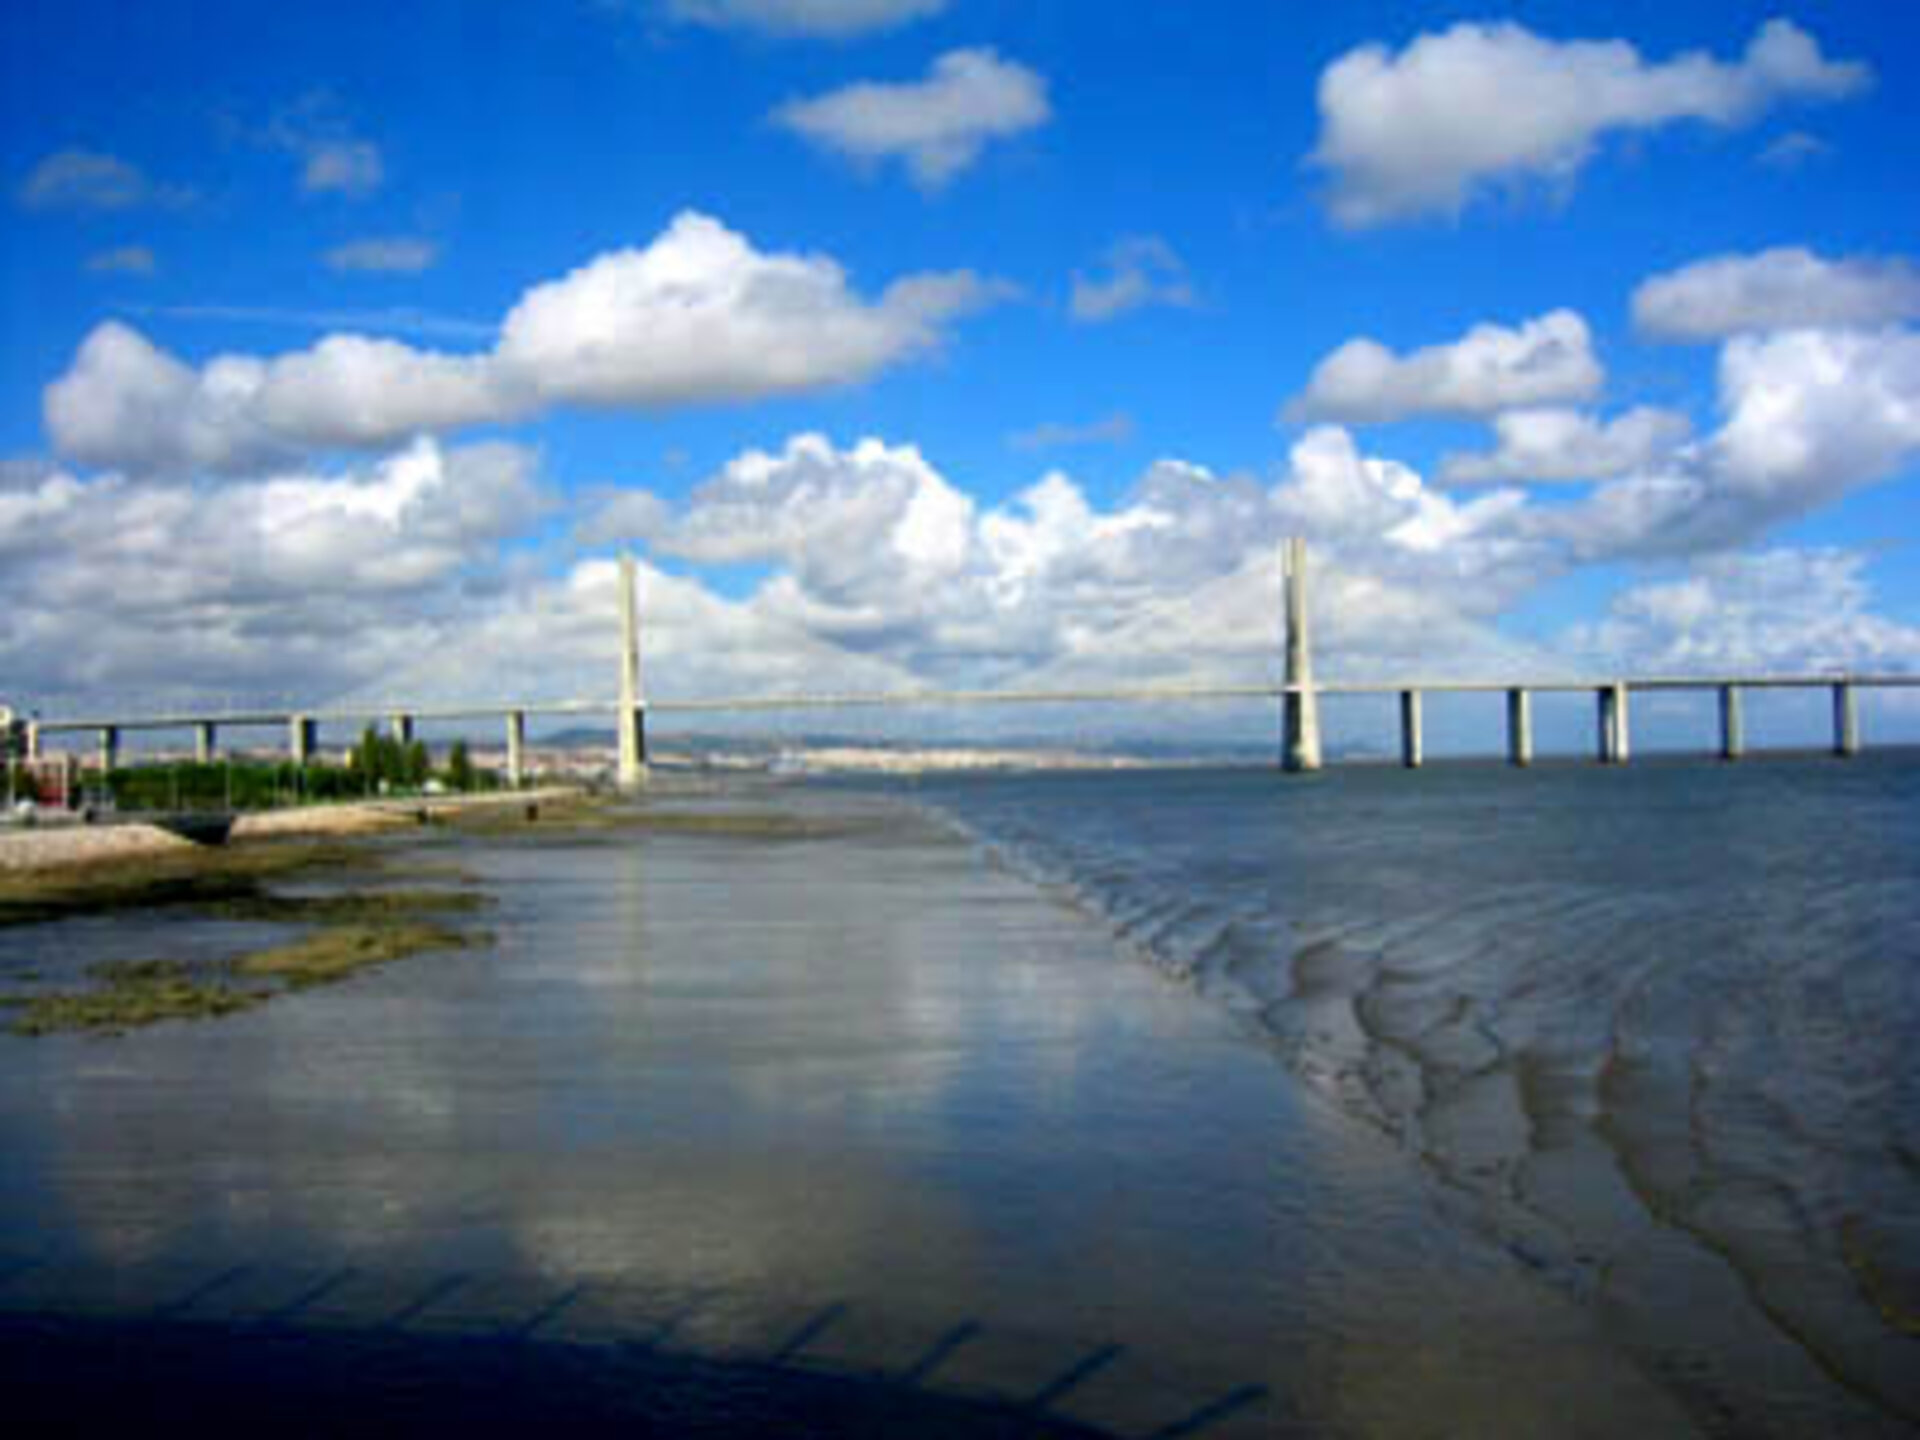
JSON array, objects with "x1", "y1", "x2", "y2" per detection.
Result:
[{"x1": 601, "y1": 428, "x2": 1546, "y2": 685}]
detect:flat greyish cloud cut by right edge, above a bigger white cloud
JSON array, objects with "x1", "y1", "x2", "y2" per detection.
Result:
[{"x1": 1634, "y1": 246, "x2": 1920, "y2": 342}]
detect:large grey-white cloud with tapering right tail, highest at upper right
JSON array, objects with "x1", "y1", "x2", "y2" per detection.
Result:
[{"x1": 1311, "y1": 19, "x2": 1872, "y2": 228}]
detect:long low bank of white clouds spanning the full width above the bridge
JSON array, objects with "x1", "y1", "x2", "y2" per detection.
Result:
[{"x1": 15, "y1": 410, "x2": 1920, "y2": 708}]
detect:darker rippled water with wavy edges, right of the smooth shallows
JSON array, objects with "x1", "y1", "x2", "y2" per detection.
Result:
[{"x1": 920, "y1": 758, "x2": 1920, "y2": 1430}]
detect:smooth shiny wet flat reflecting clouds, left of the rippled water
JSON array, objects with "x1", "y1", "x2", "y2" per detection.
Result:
[{"x1": 0, "y1": 793, "x2": 1720, "y2": 1428}]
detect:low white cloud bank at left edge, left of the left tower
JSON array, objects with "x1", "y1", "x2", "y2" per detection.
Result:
[{"x1": 0, "y1": 442, "x2": 551, "y2": 710}]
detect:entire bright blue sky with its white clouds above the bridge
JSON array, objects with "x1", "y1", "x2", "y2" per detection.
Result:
[{"x1": 0, "y1": 0, "x2": 1920, "y2": 737}]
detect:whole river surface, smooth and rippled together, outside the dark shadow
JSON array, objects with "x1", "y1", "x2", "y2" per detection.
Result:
[{"x1": 0, "y1": 760, "x2": 1920, "y2": 1438}]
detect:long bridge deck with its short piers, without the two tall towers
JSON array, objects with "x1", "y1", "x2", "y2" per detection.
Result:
[{"x1": 17, "y1": 674, "x2": 1920, "y2": 783}]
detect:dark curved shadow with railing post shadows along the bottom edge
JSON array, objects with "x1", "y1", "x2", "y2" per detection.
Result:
[{"x1": 0, "y1": 1258, "x2": 1279, "y2": 1440}]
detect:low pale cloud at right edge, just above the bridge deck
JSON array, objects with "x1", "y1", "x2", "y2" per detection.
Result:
[{"x1": 1567, "y1": 549, "x2": 1920, "y2": 674}]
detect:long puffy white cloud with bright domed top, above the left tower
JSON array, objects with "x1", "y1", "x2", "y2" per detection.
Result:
[{"x1": 44, "y1": 213, "x2": 998, "y2": 472}]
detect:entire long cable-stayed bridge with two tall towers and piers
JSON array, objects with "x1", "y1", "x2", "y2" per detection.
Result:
[{"x1": 10, "y1": 540, "x2": 1920, "y2": 787}]
